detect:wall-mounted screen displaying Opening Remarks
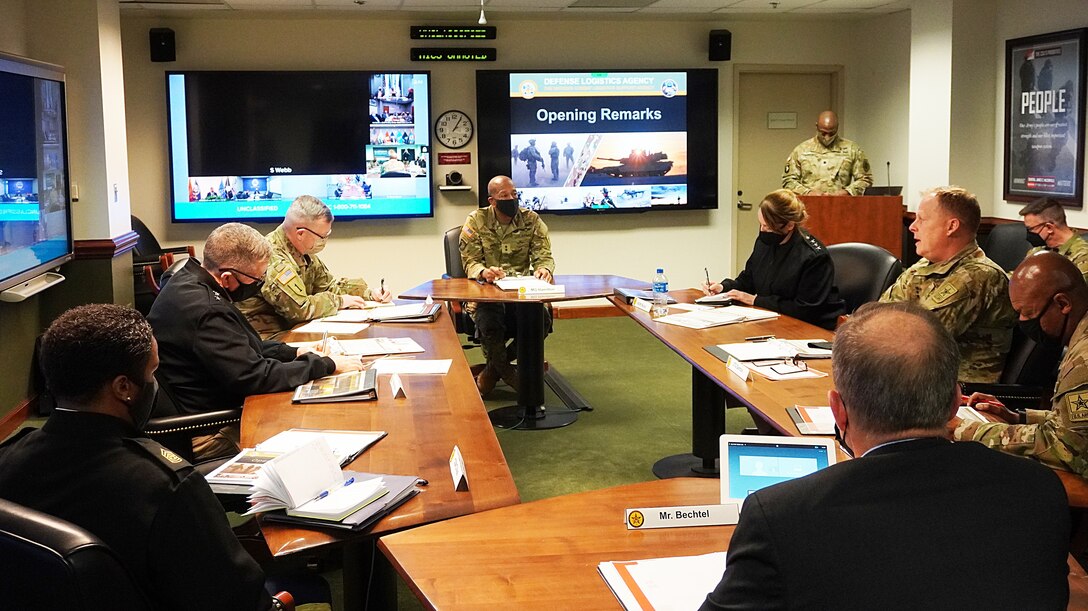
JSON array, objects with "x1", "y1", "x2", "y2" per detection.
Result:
[{"x1": 477, "y1": 70, "x2": 718, "y2": 213}]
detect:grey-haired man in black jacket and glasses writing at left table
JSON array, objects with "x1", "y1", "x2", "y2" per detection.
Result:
[{"x1": 147, "y1": 223, "x2": 362, "y2": 460}]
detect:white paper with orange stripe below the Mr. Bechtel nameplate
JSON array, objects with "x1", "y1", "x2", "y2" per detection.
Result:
[{"x1": 597, "y1": 551, "x2": 726, "y2": 611}]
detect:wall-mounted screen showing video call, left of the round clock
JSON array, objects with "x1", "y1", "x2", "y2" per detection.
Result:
[{"x1": 166, "y1": 71, "x2": 434, "y2": 223}]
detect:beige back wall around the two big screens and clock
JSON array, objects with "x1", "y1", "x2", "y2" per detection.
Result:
[{"x1": 122, "y1": 13, "x2": 910, "y2": 292}]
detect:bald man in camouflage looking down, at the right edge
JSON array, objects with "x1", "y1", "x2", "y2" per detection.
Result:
[{"x1": 953, "y1": 252, "x2": 1088, "y2": 477}]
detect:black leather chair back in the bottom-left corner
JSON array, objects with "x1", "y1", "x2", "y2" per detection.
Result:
[{"x1": 0, "y1": 499, "x2": 151, "y2": 611}]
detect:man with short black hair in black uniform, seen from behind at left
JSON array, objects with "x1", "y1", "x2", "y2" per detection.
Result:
[{"x1": 0, "y1": 304, "x2": 285, "y2": 610}]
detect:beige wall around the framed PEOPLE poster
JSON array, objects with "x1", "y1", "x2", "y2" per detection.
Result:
[{"x1": 990, "y1": 0, "x2": 1088, "y2": 223}]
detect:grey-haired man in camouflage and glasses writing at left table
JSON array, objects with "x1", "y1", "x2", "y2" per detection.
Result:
[{"x1": 237, "y1": 196, "x2": 393, "y2": 339}]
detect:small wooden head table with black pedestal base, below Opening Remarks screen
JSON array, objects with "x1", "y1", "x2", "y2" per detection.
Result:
[{"x1": 398, "y1": 275, "x2": 648, "y2": 431}]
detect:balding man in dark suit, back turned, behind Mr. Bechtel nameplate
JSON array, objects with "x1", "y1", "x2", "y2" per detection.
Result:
[{"x1": 703, "y1": 303, "x2": 1070, "y2": 610}]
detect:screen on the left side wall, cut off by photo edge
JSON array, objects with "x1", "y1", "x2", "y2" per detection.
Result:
[{"x1": 0, "y1": 53, "x2": 72, "y2": 290}]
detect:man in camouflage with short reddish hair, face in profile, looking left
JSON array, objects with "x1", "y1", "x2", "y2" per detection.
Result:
[{"x1": 880, "y1": 187, "x2": 1016, "y2": 383}]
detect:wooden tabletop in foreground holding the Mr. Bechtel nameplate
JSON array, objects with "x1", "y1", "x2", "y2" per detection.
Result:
[{"x1": 379, "y1": 477, "x2": 1088, "y2": 611}]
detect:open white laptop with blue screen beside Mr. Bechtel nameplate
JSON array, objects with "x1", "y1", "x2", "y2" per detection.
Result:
[{"x1": 720, "y1": 435, "x2": 837, "y2": 506}]
